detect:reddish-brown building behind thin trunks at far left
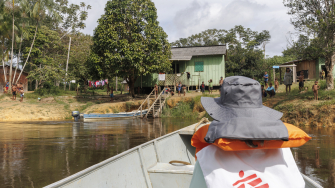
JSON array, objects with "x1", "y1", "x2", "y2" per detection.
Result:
[{"x1": 0, "y1": 65, "x2": 28, "y2": 93}]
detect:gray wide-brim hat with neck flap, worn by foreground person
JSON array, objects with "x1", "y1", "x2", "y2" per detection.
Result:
[{"x1": 201, "y1": 76, "x2": 288, "y2": 143}]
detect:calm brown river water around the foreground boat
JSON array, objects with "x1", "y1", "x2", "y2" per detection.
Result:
[{"x1": 0, "y1": 118, "x2": 335, "y2": 188}]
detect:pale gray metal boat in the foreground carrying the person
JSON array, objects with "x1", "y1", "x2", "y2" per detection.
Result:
[{"x1": 45, "y1": 124, "x2": 322, "y2": 188}]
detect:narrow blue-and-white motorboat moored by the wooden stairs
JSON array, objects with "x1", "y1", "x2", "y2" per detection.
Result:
[{"x1": 82, "y1": 110, "x2": 148, "y2": 121}]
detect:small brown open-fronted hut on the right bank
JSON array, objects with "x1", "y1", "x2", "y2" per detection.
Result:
[{"x1": 282, "y1": 58, "x2": 335, "y2": 80}]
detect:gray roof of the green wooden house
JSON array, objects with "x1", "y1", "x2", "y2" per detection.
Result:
[{"x1": 170, "y1": 45, "x2": 227, "y2": 61}]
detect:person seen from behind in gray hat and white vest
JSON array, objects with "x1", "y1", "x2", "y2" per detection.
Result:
[{"x1": 189, "y1": 76, "x2": 305, "y2": 188}]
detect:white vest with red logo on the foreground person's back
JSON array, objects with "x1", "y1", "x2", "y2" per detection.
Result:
[{"x1": 197, "y1": 145, "x2": 305, "y2": 188}]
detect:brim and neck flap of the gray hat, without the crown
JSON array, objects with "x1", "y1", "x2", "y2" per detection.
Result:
[{"x1": 201, "y1": 97, "x2": 288, "y2": 143}]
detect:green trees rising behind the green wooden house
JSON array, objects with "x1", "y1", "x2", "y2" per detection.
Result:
[{"x1": 172, "y1": 25, "x2": 295, "y2": 81}]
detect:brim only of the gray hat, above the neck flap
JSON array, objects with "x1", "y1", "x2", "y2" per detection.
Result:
[{"x1": 201, "y1": 97, "x2": 283, "y2": 122}]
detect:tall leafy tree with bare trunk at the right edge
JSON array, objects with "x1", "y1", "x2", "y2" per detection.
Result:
[{"x1": 284, "y1": 0, "x2": 335, "y2": 89}]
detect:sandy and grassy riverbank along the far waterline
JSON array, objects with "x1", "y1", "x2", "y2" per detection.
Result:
[{"x1": 0, "y1": 81, "x2": 335, "y2": 127}]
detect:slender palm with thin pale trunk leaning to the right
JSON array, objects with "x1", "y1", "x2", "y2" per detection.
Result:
[{"x1": 15, "y1": 0, "x2": 59, "y2": 83}]
